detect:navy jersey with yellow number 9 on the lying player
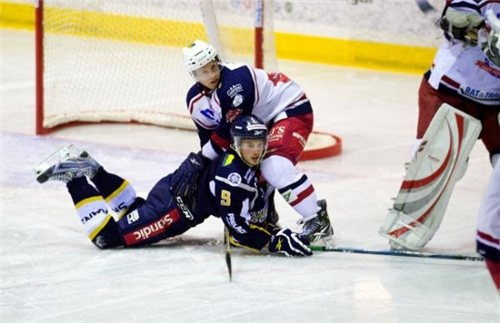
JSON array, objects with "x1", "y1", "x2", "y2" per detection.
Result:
[{"x1": 195, "y1": 151, "x2": 273, "y2": 251}]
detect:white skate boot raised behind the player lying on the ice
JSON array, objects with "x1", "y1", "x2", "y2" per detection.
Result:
[{"x1": 35, "y1": 145, "x2": 100, "y2": 183}]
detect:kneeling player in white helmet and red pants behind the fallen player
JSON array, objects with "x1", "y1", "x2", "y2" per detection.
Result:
[{"x1": 172, "y1": 40, "x2": 333, "y2": 243}]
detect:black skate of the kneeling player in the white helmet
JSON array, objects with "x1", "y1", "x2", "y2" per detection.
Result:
[{"x1": 300, "y1": 200, "x2": 333, "y2": 246}]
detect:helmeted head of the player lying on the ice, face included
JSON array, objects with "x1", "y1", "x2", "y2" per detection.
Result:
[{"x1": 231, "y1": 115, "x2": 267, "y2": 167}]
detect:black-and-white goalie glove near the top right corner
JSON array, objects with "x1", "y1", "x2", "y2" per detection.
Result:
[{"x1": 439, "y1": 8, "x2": 484, "y2": 46}]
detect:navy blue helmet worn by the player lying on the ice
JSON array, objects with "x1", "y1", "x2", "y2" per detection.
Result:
[{"x1": 231, "y1": 115, "x2": 268, "y2": 165}]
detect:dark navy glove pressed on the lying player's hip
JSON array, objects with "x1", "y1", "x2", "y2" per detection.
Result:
[{"x1": 170, "y1": 152, "x2": 208, "y2": 197}]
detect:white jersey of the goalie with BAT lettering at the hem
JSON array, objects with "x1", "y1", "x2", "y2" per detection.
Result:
[{"x1": 429, "y1": 0, "x2": 500, "y2": 106}]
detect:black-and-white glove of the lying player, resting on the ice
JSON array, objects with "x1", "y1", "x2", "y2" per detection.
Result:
[{"x1": 269, "y1": 229, "x2": 312, "y2": 257}]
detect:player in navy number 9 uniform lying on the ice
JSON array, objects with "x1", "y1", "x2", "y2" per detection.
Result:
[{"x1": 35, "y1": 116, "x2": 312, "y2": 256}]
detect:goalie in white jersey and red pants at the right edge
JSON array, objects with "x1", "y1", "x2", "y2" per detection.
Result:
[{"x1": 380, "y1": 0, "x2": 500, "y2": 250}]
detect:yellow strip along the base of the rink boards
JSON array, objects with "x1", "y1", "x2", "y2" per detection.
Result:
[{"x1": 0, "y1": 2, "x2": 436, "y2": 73}]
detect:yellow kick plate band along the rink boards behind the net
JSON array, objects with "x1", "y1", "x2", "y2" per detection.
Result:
[{"x1": 0, "y1": 2, "x2": 437, "y2": 73}]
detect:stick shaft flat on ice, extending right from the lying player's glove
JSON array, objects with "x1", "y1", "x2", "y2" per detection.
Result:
[{"x1": 310, "y1": 246, "x2": 484, "y2": 261}]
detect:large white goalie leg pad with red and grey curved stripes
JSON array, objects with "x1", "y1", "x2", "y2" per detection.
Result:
[{"x1": 379, "y1": 103, "x2": 481, "y2": 250}]
